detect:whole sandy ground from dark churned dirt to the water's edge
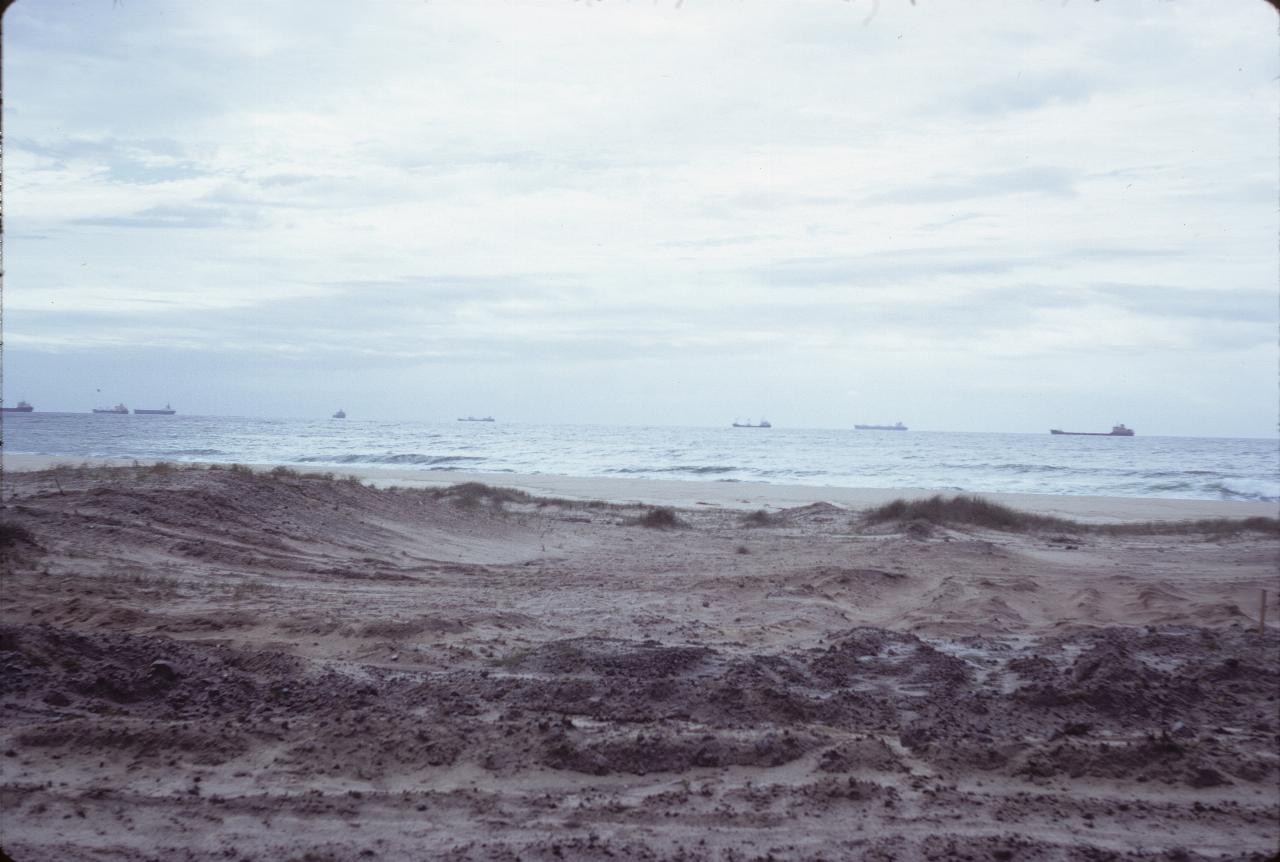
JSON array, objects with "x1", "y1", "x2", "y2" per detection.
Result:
[{"x1": 0, "y1": 456, "x2": 1280, "y2": 862}]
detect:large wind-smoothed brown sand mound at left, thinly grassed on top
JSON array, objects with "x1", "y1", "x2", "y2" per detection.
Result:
[{"x1": 8, "y1": 468, "x2": 539, "y2": 580}]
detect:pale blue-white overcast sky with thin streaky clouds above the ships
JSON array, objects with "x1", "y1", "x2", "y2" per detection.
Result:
[{"x1": 3, "y1": 0, "x2": 1280, "y2": 437}]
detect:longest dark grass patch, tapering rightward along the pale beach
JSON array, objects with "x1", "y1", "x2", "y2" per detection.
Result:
[{"x1": 859, "y1": 494, "x2": 1280, "y2": 538}]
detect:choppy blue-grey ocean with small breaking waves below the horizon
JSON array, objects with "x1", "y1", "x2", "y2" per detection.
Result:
[{"x1": 3, "y1": 412, "x2": 1280, "y2": 501}]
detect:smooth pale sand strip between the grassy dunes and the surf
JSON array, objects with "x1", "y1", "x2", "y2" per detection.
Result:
[{"x1": 3, "y1": 453, "x2": 1280, "y2": 524}]
